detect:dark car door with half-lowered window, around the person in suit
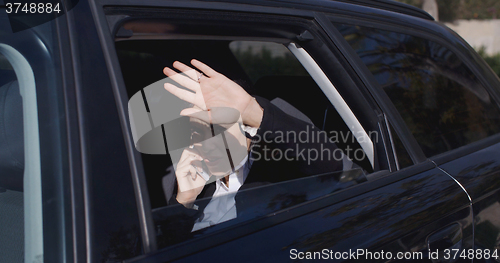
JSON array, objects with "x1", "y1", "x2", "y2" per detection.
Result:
[{"x1": 91, "y1": 1, "x2": 473, "y2": 262}]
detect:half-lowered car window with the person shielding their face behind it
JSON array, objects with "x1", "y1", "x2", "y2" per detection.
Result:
[{"x1": 115, "y1": 16, "x2": 372, "y2": 252}]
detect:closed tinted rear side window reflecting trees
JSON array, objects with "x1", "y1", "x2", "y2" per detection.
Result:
[{"x1": 336, "y1": 24, "x2": 500, "y2": 157}]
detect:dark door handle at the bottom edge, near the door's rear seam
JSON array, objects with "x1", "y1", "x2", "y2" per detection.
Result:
[{"x1": 427, "y1": 223, "x2": 463, "y2": 263}]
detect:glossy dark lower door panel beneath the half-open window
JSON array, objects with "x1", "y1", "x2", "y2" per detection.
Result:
[{"x1": 130, "y1": 163, "x2": 472, "y2": 262}]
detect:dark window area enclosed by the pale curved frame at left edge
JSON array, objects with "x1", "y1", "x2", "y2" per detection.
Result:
[{"x1": 0, "y1": 50, "x2": 24, "y2": 262}]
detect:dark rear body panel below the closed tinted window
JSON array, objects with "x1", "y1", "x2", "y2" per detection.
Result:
[{"x1": 440, "y1": 132, "x2": 500, "y2": 260}]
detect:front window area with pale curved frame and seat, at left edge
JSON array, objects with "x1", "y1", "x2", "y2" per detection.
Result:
[{"x1": 0, "y1": 16, "x2": 43, "y2": 262}]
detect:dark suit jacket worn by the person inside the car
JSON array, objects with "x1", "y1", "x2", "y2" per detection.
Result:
[{"x1": 155, "y1": 97, "x2": 343, "y2": 246}]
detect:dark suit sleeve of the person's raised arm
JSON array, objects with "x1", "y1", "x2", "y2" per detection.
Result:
[{"x1": 252, "y1": 96, "x2": 343, "y2": 176}]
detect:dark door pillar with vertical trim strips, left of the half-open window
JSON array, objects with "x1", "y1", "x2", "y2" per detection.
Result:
[{"x1": 58, "y1": 1, "x2": 144, "y2": 262}]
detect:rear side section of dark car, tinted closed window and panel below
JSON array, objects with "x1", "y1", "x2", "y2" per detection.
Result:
[{"x1": 322, "y1": 4, "x2": 500, "y2": 260}]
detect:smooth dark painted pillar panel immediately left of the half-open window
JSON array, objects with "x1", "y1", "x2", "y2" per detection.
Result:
[{"x1": 63, "y1": 1, "x2": 142, "y2": 262}]
